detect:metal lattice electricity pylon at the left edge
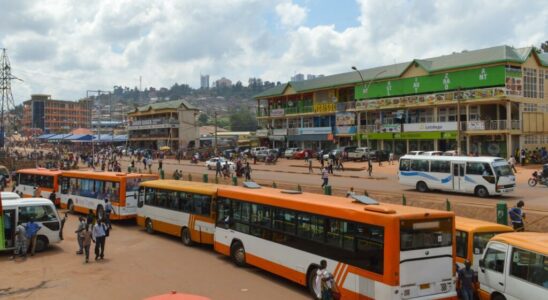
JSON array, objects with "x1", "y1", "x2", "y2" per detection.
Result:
[{"x1": 0, "y1": 48, "x2": 22, "y2": 148}]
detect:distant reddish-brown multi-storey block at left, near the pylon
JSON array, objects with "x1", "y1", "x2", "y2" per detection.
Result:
[{"x1": 23, "y1": 95, "x2": 92, "y2": 133}]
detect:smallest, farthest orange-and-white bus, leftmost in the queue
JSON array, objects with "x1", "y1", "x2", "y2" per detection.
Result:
[{"x1": 15, "y1": 168, "x2": 63, "y2": 206}]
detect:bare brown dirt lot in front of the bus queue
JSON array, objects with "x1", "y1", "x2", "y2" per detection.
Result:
[{"x1": 0, "y1": 215, "x2": 309, "y2": 299}]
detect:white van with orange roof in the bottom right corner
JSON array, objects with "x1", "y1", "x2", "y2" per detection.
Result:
[{"x1": 478, "y1": 232, "x2": 548, "y2": 300}]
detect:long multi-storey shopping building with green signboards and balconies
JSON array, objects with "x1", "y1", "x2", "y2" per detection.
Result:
[{"x1": 255, "y1": 46, "x2": 548, "y2": 157}]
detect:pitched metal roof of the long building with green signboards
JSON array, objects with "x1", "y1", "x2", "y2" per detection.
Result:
[{"x1": 254, "y1": 45, "x2": 548, "y2": 98}]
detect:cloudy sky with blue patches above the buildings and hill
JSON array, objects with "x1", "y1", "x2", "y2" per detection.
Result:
[{"x1": 0, "y1": 0, "x2": 548, "y2": 103}]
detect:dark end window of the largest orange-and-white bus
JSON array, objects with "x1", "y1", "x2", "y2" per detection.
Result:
[{"x1": 400, "y1": 218, "x2": 453, "y2": 251}]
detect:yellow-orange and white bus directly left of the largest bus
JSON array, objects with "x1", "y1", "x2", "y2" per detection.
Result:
[{"x1": 137, "y1": 180, "x2": 217, "y2": 246}]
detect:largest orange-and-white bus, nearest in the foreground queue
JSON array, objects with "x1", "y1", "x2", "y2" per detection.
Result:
[{"x1": 214, "y1": 186, "x2": 457, "y2": 299}]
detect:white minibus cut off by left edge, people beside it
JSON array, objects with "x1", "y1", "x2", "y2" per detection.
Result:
[{"x1": 2, "y1": 198, "x2": 63, "y2": 252}]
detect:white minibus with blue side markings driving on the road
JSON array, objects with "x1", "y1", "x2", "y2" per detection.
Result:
[{"x1": 398, "y1": 155, "x2": 516, "y2": 198}]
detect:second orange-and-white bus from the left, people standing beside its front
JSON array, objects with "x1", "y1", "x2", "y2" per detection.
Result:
[{"x1": 59, "y1": 171, "x2": 158, "y2": 220}]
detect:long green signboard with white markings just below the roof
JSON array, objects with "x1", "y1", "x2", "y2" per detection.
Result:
[{"x1": 354, "y1": 66, "x2": 506, "y2": 100}]
